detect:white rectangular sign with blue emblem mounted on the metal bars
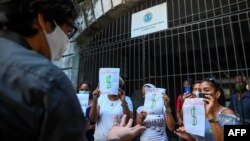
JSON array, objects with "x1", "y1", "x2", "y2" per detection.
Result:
[{"x1": 131, "y1": 2, "x2": 168, "y2": 38}]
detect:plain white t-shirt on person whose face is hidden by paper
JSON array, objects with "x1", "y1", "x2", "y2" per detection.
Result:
[{"x1": 94, "y1": 95, "x2": 133, "y2": 141}]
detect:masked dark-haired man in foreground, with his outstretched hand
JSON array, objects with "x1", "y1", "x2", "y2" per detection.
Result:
[{"x1": 0, "y1": 0, "x2": 143, "y2": 141}]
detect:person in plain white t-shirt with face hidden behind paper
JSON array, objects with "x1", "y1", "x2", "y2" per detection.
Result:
[{"x1": 90, "y1": 78, "x2": 133, "y2": 141}]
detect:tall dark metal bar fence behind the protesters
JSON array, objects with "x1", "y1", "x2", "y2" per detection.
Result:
[{"x1": 78, "y1": 0, "x2": 250, "y2": 106}]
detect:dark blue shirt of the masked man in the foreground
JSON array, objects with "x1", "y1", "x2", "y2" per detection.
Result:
[{"x1": 0, "y1": 31, "x2": 84, "y2": 141}]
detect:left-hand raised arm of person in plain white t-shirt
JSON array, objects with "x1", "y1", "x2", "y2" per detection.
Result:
[{"x1": 89, "y1": 88, "x2": 100, "y2": 122}]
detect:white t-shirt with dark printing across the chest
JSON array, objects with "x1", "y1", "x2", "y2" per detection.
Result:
[{"x1": 136, "y1": 106, "x2": 168, "y2": 141}]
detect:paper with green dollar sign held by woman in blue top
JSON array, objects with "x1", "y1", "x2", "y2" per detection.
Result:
[{"x1": 182, "y1": 98, "x2": 205, "y2": 137}]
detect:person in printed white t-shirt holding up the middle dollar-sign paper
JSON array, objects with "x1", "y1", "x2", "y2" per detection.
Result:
[{"x1": 136, "y1": 88, "x2": 175, "y2": 141}]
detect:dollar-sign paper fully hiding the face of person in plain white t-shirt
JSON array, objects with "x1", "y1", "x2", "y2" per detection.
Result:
[{"x1": 99, "y1": 68, "x2": 120, "y2": 95}]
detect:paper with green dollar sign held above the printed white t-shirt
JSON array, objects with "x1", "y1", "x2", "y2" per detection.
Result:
[{"x1": 143, "y1": 88, "x2": 166, "y2": 114}]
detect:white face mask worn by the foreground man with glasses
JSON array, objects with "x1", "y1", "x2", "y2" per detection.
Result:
[{"x1": 44, "y1": 23, "x2": 69, "y2": 61}]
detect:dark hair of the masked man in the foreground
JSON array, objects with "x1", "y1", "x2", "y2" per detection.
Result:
[{"x1": 0, "y1": 0, "x2": 79, "y2": 37}]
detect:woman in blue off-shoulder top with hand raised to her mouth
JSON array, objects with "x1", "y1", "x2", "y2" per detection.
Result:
[{"x1": 175, "y1": 79, "x2": 239, "y2": 141}]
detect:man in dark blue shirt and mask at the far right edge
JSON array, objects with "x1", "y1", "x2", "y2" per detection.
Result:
[{"x1": 228, "y1": 75, "x2": 250, "y2": 125}]
